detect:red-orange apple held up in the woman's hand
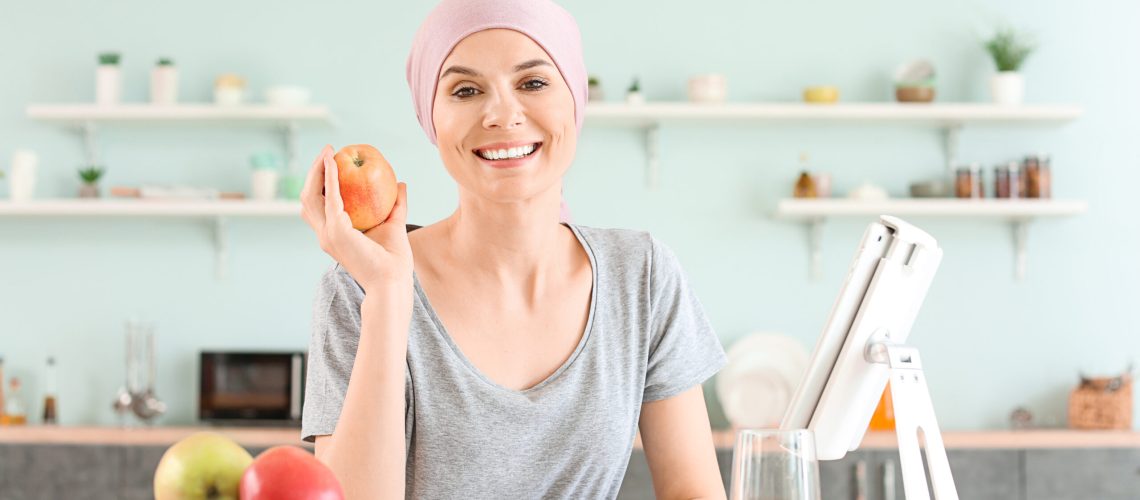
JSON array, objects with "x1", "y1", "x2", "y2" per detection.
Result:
[{"x1": 333, "y1": 145, "x2": 397, "y2": 231}]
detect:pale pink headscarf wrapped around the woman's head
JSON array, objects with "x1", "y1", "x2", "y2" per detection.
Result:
[{"x1": 407, "y1": 0, "x2": 587, "y2": 222}]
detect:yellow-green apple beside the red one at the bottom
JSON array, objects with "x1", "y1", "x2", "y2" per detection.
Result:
[{"x1": 154, "y1": 432, "x2": 253, "y2": 500}]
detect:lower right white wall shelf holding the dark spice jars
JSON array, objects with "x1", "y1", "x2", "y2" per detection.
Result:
[{"x1": 774, "y1": 198, "x2": 1089, "y2": 280}]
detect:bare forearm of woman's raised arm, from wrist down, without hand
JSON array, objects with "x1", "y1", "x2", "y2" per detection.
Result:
[{"x1": 316, "y1": 289, "x2": 412, "y2": 499}]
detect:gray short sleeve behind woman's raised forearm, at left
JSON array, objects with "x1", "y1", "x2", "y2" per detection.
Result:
[{"x1": 301, "y1": 264, "x2": 364, "y2": 442}]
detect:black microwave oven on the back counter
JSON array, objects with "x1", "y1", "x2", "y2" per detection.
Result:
[{"x1": 198, "y1": 351, "x2": 306, "y2": 426}]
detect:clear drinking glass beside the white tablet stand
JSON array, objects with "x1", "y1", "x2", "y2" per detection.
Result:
[{"x1": 728, "y1": 429, "x2": 820, "y2": 500}]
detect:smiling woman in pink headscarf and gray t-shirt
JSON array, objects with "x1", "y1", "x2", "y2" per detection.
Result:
[{"x1": 302, "y1": 0, "x2": 725, "y2": 499}]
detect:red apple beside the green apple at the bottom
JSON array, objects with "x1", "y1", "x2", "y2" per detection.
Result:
[{"x1": 241, "y1": 445, "x2": 344, "y2": 500}]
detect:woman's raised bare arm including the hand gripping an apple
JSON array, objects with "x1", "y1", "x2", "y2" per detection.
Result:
[{"x1": 301, "y1": 146, "x2": 414, "y2": 500}]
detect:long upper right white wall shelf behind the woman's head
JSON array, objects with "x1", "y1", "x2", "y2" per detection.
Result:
[{"x1": 585, "y1": 103, "x2": 1083, "y2": 188}]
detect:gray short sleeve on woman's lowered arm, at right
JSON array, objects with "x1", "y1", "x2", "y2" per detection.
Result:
[{"x1": 643, "y1": 238, "x2": 727, "y2": 402}]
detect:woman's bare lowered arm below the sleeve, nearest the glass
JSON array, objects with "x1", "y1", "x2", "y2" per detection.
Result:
[{"x1": 638, "y1": 385, "x2": 725, "y2": 499}]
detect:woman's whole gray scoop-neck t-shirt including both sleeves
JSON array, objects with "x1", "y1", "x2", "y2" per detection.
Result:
[{"x1": 301, "y1": 224, "x2": 726, "y2": 499}]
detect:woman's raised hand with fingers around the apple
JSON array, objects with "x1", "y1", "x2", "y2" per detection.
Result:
[{"x1": 301, "y1": 146, "x2": 413, "y2": 294}]
